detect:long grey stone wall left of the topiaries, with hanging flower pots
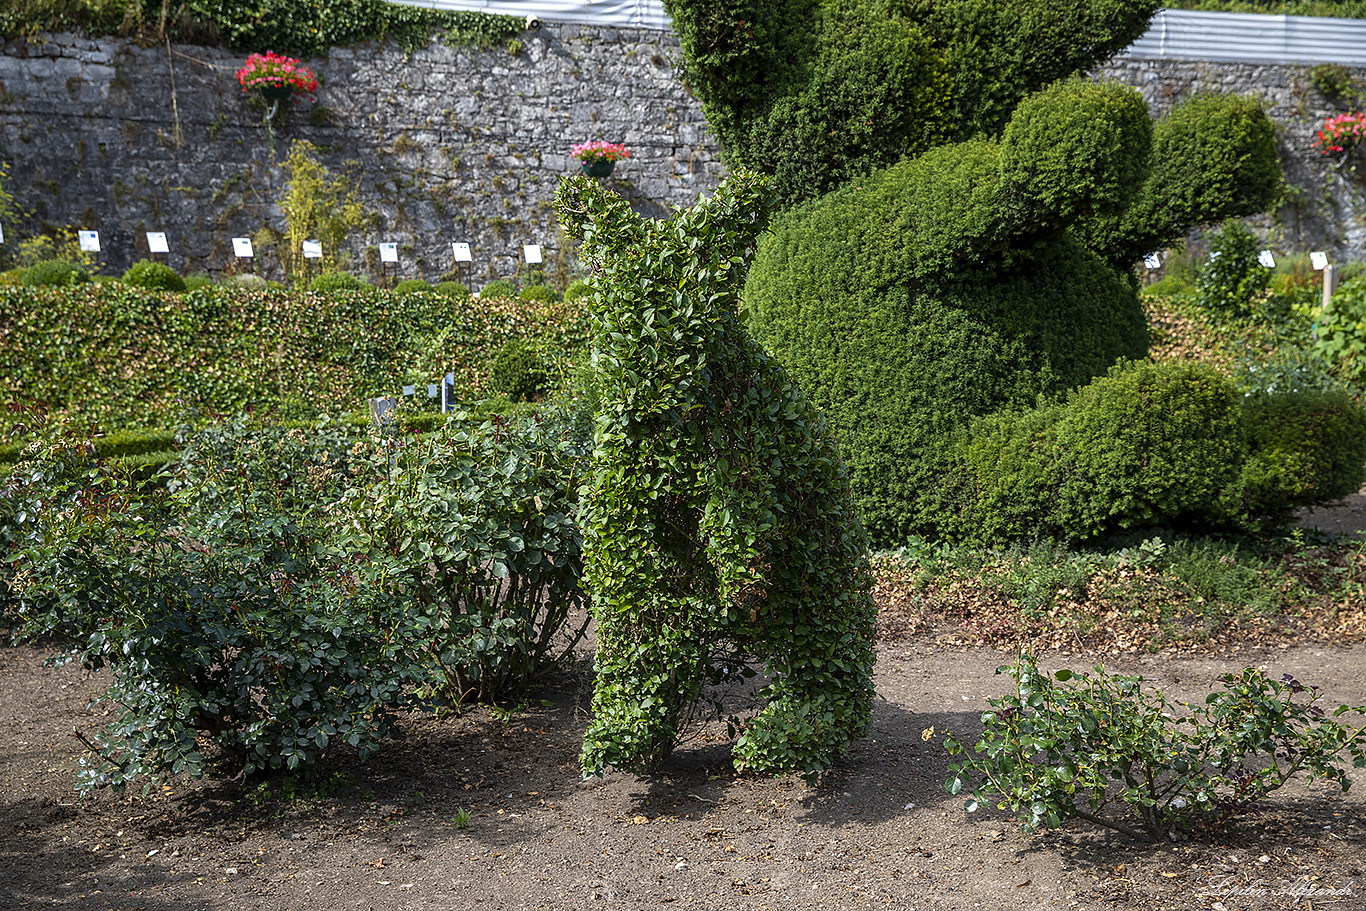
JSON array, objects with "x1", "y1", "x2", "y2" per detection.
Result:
[{"x1": 0, "y1": 25, "x2": 723, "y2": 282}]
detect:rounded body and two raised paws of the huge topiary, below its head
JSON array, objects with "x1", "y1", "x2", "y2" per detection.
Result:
[{"x1": 743, "y1": 81, "x2": 1279, "y2": 542}]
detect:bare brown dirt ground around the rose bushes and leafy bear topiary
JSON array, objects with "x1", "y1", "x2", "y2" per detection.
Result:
[{"x1": 0, "y1": 641, "x2": 1366, "y2": 911}]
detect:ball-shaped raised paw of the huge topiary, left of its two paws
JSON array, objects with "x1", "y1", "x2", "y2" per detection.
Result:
[{"x1": 1000, "y1": 81, "x2": 1153, "y2": 227}]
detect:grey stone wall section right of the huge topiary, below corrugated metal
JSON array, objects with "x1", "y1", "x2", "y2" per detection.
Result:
[{"x1": 1096, "y1": 60, "x2": 1366, "y2": 261}]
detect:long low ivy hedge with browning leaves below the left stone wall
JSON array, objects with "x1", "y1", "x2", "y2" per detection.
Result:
[{"x1": 0, "y1": 283, "x2": 586, "y2": 429}]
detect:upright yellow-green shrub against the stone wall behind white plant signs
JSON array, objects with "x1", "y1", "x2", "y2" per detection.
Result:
[{"x1": 280, "y1": 139, "x2": 365, "y2": 284}]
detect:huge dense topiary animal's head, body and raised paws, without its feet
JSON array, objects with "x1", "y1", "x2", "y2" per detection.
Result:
[{"x1": 667, "y1": 0, "x2": 1300, "y2": 542}]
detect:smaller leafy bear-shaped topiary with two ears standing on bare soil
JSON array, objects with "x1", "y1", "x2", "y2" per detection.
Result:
[{"x1": 556, "y1": 171, "x2": 874, "y2": 774}]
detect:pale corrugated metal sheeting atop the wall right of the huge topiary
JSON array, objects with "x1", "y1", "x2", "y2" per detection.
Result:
[{"x1": 1120, "y1": 10, "x2": 1366, "y2": 67}]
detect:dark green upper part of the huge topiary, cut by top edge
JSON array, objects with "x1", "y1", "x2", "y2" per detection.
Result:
[{"x1": 665, "y1": 0, "x2": 1157, "y2": 204}]
